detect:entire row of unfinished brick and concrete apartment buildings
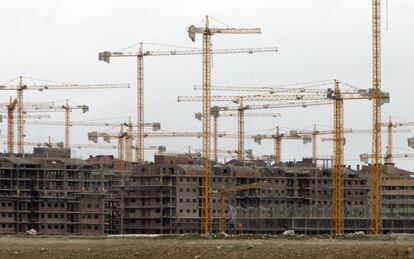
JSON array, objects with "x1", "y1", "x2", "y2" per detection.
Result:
[{"x1": 0, "y1": 148, "x2": 414, "y2": 235}]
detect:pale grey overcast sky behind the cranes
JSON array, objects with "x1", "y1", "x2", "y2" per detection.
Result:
[{"x1": 0, "y1": 0, "x2": 414, "y2": 170}]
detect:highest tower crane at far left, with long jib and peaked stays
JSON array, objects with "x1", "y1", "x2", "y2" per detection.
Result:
[{"x1": 0, "y1": 76, "x2": 129, "y2": 154}]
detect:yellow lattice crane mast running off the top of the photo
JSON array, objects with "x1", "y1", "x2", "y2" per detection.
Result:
[{"x1": 370, "y1": 0, "x2": 382, "y2": 234}]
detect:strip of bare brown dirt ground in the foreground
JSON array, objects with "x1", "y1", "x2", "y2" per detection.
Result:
[{"x1": 0, "y1": 236, "x2": 414, "y2": 259}]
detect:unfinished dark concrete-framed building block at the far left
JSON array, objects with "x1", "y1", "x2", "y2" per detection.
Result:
[{"x1": 0, "y1": 149, "x2": 118, "y2": 235}]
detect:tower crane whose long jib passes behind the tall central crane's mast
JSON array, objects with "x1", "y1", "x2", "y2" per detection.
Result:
[{"x1": 99, "y1": 42, "x2": 277, "y2": 167}]
